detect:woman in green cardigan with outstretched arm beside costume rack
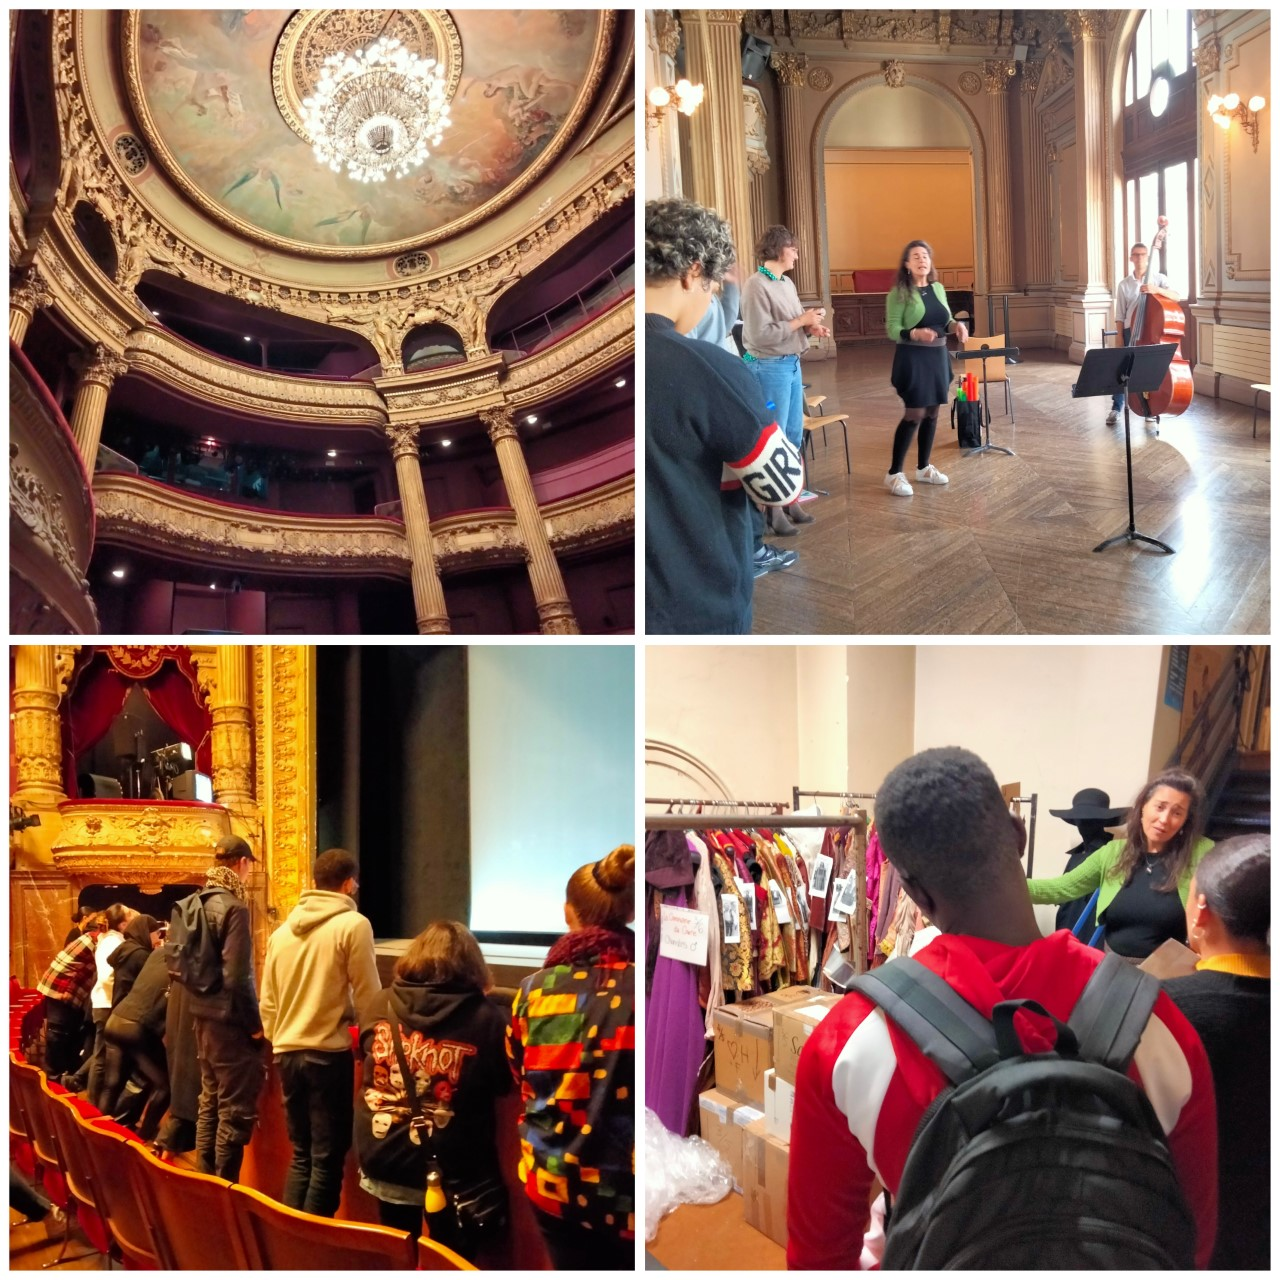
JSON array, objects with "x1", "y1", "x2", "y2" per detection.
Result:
[{"x1": 1027, "y1": 769, "x2": 1213, "y2": 964}]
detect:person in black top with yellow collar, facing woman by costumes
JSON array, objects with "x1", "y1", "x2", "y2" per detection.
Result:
[{"x1": 1164, "y1": 835, "x2": 1271, "y2": 1271}]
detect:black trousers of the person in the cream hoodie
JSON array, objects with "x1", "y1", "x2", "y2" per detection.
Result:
[{"x1": 275, "y1": 1050, "x2": 356, "y2": 1217}]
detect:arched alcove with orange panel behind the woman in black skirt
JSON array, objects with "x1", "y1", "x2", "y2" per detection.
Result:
[{"x1": 812, "y1": 74, "x2": 986, "y2": 339}]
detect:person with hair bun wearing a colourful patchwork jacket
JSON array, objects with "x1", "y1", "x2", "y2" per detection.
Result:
[{"x1": 507, "y1": 845, "x2": 636, "y2": 1271}]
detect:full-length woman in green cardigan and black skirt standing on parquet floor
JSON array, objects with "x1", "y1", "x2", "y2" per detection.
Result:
[{"x1": 884, "y1": 241, "x2": 969, "y2": 498}]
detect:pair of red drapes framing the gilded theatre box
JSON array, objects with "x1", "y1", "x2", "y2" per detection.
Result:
[{"x1": 63, "y1": 654, "x2": 212, "y2": 800}]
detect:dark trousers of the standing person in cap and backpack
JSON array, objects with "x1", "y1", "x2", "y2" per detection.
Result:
[{"x1": 196, "y1": 1018, "x2": 266, "y2": 1183}]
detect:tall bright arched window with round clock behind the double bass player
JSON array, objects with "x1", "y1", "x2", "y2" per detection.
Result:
[{"x1": 1121, "y1": 9, "x2": 1199, "y2": 362}]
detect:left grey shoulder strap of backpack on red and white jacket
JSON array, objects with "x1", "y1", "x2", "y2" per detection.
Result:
[{"x1": 849, "y1": 956, "x2": 1000, "y2": 1084}]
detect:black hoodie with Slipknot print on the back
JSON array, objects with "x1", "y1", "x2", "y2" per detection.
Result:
[{"x1": 355, "y1": 978, "x2": 512, "y2": 1190}]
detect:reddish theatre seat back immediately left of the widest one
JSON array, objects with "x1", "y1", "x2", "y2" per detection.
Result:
[{"x1": 124, "y1": 1142, "x2": 248, "y2": 1271}]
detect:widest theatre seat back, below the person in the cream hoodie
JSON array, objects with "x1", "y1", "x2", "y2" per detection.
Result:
[{"x1": 230, "y1": 1185, "x2": 417, "y2": 1271}]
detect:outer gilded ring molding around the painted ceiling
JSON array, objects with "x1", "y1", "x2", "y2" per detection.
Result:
[{"x1": 120, "y1": 9, "x2": 617, "y2": 261}]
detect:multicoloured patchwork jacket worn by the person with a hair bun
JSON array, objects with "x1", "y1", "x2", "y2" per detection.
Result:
[{"x1": 507, "y1": 928, "x2": 635, "y2": 1240}]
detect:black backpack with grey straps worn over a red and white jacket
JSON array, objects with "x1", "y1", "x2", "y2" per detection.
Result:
[{"x1": 851, "y1": 954, "x2": 1196, "y2": 1271}]
